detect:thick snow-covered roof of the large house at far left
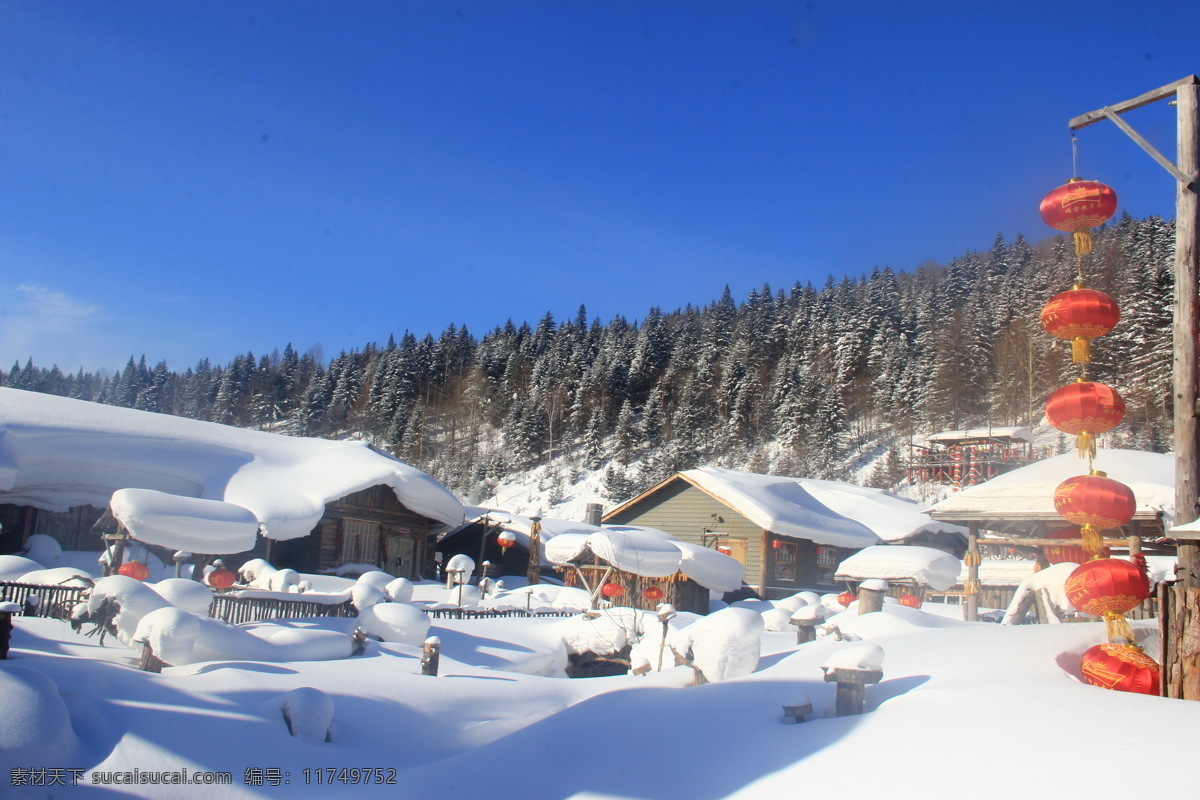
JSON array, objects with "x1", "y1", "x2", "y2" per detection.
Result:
[{"x1": 0, "y1": 389, "x2": 463, "y2": 553}]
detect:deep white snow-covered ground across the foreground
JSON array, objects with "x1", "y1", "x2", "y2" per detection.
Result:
[{"x1": 0, "y1": 578, "x2": 1200, "y2": 800}]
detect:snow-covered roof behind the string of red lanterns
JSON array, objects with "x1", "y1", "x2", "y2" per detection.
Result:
[{"x1": 929, "y1": 450, "x2": 1175, "y2": 527}]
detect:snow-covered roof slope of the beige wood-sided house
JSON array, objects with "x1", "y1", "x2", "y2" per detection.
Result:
[{"x1": 680, "y1": 467, "x2": 966, "y2": 548}]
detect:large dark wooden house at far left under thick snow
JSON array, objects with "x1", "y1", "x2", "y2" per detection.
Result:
[{"x1": 0, "y1": 389, "x2": 463, "y2": 577}]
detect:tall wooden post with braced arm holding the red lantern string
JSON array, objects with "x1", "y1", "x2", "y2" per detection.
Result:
[{"x1": 1068, "y1": 76, "x2": 1200, "y2": 700}]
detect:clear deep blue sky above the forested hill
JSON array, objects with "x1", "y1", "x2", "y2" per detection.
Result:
[{"x1": 0, "y1": 0, "x2": 1200, "y2": 371}]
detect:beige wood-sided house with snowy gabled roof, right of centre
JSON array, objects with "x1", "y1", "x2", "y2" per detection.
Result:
[{"x1": 604, "y1": 468, "x2": 962, "y2": 599}]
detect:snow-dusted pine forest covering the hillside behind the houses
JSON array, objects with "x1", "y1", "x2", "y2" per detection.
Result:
[{"x1": 0, "y1": 216, "x2": 1174, "y2": 506}]
